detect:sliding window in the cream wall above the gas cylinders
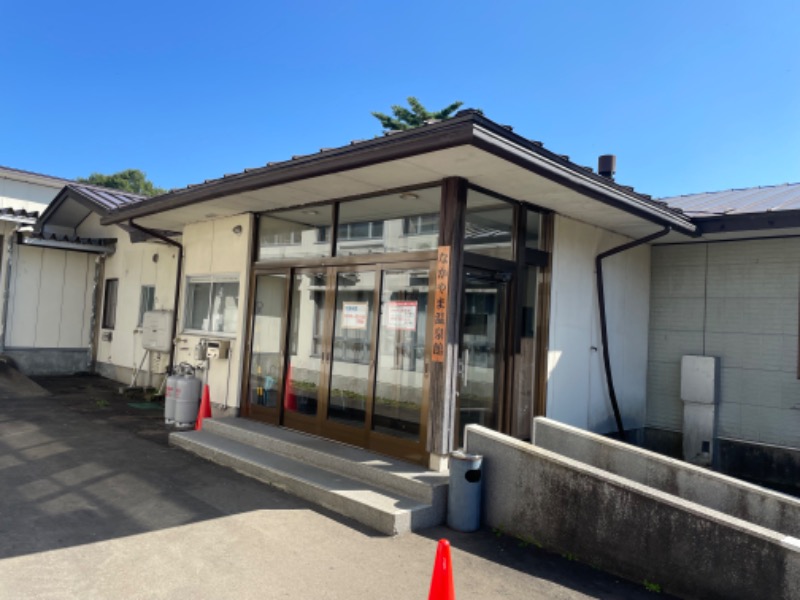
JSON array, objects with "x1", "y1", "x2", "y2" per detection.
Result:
[{"x1": 183, "y1": 276, "x2": 239, "y2": 334}]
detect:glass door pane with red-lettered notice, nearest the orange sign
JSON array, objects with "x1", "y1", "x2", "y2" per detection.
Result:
[{"x1": 372, "y1": 270, "x2": 429, "y2": 439}]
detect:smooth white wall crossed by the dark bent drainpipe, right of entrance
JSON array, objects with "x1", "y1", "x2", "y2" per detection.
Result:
[{"x1": 547, "y1": 216, "x2": 650, "y2": 433}]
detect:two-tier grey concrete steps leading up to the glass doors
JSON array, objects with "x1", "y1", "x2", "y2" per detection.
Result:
[{"x1": 169, "y1": 418, "x2": 448, "y2": 535}]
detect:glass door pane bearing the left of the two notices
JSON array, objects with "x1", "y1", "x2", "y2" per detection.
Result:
[{"x1": 328, "y1": 271, "x2": 375, "y2": 426}]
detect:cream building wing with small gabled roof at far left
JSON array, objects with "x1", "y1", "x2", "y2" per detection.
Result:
[{"x1": 0, "y1": 169, "x2": 178, "y2": 385}]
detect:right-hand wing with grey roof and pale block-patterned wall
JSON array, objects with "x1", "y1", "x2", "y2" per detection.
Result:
[{"x1": 647, "y1": 184, "x2": 800, "y2": 493}]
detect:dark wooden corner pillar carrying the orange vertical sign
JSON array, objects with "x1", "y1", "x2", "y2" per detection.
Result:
[{"x1": 427, "y1": 177, "x2": 467, "y2": 463}]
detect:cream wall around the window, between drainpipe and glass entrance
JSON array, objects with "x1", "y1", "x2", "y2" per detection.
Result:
[{"x1": 175, "y1": 214, "x2": 253, "y2": 407}]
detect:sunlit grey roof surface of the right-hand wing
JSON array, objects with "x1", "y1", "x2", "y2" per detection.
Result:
[{"x1": 661, "y1": 183, "x2": 800, "y2": 218}]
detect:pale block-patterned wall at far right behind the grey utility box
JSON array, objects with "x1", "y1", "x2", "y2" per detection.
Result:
[{"x1": 647, "y1": 238, "x2": 800, "y2": 448}]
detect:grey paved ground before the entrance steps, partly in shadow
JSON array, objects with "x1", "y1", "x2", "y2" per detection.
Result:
[{"x1": 0, "y1": 378, "x2": 676, "y2": 600}]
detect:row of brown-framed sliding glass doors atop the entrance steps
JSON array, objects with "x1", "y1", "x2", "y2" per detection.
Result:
[{"x1": 247, "y1": 262, "x2": 432, "y2": 462}]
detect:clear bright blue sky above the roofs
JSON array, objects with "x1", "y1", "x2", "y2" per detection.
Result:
[{"x1": 0, "y1": 0, "x2": 800, "y2": 197}]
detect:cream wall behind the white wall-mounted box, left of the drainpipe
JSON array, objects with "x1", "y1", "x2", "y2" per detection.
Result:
[{"x1": 91, "y1": 214, "x2": 178, "y2": 385}]
